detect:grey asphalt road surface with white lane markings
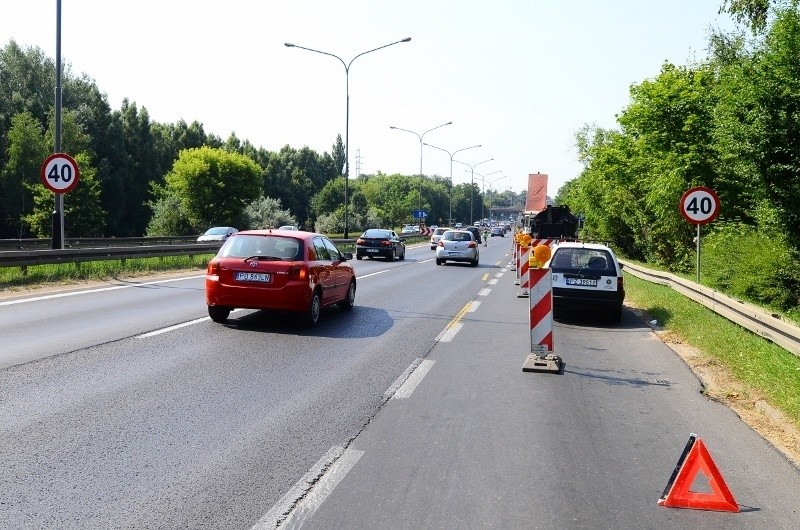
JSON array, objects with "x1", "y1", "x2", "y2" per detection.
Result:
[{"x1": 0, "y1": 238, "x2": 800, "y2": 529}]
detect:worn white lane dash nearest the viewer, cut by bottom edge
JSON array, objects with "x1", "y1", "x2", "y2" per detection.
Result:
[{"x1": 251, "y1": 446, "x2": 364, "y2": 530}]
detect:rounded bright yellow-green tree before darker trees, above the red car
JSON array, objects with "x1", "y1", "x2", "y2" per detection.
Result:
[{"x1": 165, "y1": 147, "x2": 261, "y2": 230}]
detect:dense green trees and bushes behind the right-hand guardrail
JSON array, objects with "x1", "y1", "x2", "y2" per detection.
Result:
[{"x1": 557, "y1": 0, "x2": 800, "y2": 310}]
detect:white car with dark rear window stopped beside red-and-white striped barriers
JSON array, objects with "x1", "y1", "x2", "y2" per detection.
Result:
[{"x1": 545, "y1": 242, "x2": 625, "y2": 322}]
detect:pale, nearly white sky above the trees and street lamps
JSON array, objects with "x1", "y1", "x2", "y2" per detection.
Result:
[{"x1": 0, "y1": 0, "x2": 734, "y2": 197}]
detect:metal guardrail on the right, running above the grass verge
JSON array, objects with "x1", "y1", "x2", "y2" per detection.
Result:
[{"x1": 620, "y1": 260, "x2": 800, "y2": 357}]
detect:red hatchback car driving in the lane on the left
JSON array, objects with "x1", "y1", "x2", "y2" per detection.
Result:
[{"x1": 206, "y1": 230, "x2": 356, "y2": 326}]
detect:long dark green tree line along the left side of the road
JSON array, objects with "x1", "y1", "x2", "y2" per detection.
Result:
[{"x1": 0, "y1": 40, "x2": 524, "y2": 238}]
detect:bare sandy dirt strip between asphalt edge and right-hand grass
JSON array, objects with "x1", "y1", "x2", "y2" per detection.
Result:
[{"x1": 626, "y1": 301, "x2": 800, "y2": 467}]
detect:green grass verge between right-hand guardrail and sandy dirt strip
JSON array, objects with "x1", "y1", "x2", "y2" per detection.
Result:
[{"x1": 625, "y1": 274, "x2": 800, "y2": 429}]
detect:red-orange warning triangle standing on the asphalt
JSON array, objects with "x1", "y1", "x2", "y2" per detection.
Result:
[{"x1": 658, "y1": 434, "x2": 739, "y2": 512}]
